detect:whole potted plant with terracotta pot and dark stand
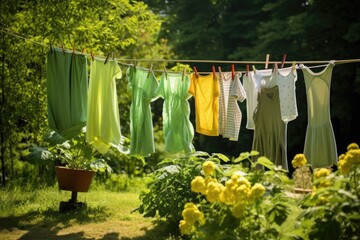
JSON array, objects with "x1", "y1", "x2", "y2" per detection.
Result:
[{"x1": 26, "y1": 128, "x2": 112, "y2": 211}]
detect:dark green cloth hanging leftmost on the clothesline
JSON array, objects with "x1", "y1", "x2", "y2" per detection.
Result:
[{"x1": 46, "y1": 49, "x2": 88, "y2": 138}]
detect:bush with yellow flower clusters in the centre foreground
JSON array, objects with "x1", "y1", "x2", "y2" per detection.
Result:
[{"x1": 179, "y1": 151, "x2": 296, "y2": 239}]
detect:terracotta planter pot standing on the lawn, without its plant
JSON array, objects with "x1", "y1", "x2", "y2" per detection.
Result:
[{"x1": 55, "y1": 166, "x2": 95, "y2": 192}]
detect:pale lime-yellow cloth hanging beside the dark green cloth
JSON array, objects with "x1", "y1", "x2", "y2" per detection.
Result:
[{"x1": 86, "y1": 58, "x2": 129, "y2": 154}]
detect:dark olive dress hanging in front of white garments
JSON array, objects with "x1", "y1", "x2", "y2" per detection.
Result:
[{"x1": 252, "y1": 86, "x2": 288, "y2": 170}]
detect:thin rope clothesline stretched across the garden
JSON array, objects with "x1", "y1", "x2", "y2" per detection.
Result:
[{"x1": 0, "y1": 27, "x2": 360, "y2": 68}]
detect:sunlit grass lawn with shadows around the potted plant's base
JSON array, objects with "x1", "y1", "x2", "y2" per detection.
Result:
[{"x1": 0, "y1": 180, "x2": 180, "y2": 240}]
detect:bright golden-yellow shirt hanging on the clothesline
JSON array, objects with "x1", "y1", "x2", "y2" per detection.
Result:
[{"x1": 189, "y1": 73, "x2": 219, "y2": 136}]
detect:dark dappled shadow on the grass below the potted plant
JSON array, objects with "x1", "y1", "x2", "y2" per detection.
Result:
[{"x1": 0, "y1": 204, "x2": 110, "y2": 240}]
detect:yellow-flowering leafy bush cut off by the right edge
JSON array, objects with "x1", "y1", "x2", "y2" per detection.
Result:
[{"x1": 298, "y1": 144, "x2": 360, "y2": 240}]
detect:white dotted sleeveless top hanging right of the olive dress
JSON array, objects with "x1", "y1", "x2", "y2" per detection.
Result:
[{"x1": 276, "y1": 67, "x2": 298, "y2": 122}]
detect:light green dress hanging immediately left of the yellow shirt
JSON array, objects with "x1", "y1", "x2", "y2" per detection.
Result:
[{"x1": 156, "y1": 73, "x2": 195, "y2": 153}]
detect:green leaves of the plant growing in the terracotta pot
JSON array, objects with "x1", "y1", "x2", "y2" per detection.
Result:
[{"x1": 26, "y1": 128, "x2": 112, "y2": 172}]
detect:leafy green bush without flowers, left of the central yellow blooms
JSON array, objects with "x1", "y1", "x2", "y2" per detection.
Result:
[{"x1": 136, "y1": 152, "x2": 229, "y2": 226}]
